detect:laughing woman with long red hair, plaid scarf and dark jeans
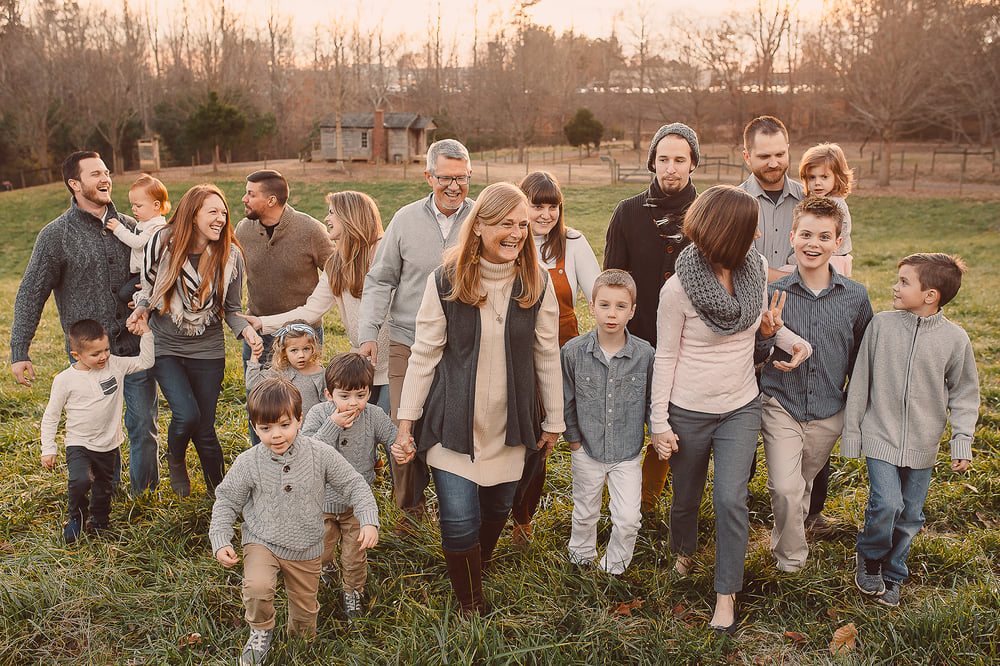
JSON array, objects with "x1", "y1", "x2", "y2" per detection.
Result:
[{"x1": 128, "y1": 185, "x2": 263, "y2": 497}]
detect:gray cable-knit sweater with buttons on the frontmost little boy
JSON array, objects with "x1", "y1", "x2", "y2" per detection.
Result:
[{"x1": 208, "y1": 433, "x2": 379, "y2": 561}]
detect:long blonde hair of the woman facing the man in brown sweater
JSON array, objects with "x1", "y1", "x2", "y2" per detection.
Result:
[{"x1": 326, "y1": 190, "x2": 382, "y2": 298}]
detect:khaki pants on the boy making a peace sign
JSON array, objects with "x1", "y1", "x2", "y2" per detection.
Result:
[{"x1": 760, "y1": 395, "x2": 844, "y2": 571}]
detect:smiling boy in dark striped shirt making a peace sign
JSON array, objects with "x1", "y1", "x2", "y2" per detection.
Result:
[{"x1": 759, "y1": 196, "x2": 872, "y2": 572}]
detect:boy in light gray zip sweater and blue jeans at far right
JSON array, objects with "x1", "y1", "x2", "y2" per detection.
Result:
[{"x1": 840, "y1": 252, "x2": 979, "y2": 606}]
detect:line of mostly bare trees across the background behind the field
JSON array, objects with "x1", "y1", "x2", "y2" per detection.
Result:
[{"x1": 0, "y1": 0, "x2": 1000, "y2": 184}]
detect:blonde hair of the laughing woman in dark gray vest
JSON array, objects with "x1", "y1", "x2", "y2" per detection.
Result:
[{"x1": 443, "y1": 183, "x2": 545, "y2": 308}]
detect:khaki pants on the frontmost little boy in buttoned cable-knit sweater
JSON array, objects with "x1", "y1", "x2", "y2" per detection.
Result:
[{"x1": 243, "y1": 543, "x2": 320, "y2": 639}]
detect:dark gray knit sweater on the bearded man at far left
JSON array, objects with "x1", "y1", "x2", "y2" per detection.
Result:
[{"x1": 10, "y1": 199, "x2": 139, "y2": 363}]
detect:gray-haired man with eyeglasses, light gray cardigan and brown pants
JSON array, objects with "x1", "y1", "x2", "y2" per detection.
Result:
[{"x1": 358, "y1": 139, "x2": 474, "y2": 534}]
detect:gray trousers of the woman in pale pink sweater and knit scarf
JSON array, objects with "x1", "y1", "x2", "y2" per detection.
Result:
[{"x1": 669, "y1": 396, "x2": 761, "y2": 594}]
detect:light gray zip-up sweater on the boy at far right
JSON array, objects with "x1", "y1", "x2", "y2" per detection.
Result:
[{"x1": 840, "y1": 310, "x2": 979, "y2": 469}]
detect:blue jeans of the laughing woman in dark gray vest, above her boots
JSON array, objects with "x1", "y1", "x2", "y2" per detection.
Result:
[{"x1": 430, "y1": 467, "x2": 517, "y2": 553}]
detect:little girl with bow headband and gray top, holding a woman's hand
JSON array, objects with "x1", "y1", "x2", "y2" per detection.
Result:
[{"x1": 246, "y1": 320, "x2": 326, "y2": 414}]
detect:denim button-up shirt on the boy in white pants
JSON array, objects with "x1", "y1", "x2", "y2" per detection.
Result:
[{"x1": 560, "y1": 330, "x2": 653, "y2": 464}]
